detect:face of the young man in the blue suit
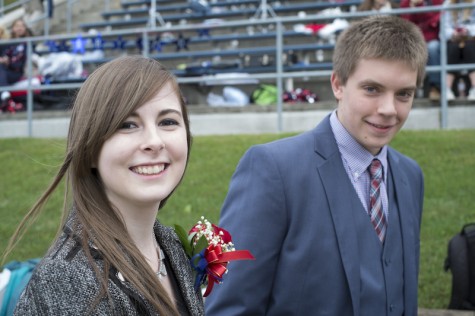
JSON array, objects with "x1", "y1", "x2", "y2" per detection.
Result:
[{"x1": 331, "y1": 59, "x2": 417, "y2": 155}]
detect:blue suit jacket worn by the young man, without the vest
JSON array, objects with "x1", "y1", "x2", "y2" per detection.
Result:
[{"x1": 205, "y1": 117, "x2": 423, "y2": 316}]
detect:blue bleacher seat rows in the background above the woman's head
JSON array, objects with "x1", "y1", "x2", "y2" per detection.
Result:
[{"x1": 28, "y1": 0, "x2": 361, "y2": 106}]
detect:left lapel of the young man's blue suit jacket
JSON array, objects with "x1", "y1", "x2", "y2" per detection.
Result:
[{"x1": 315, "y1": 117, "x2": 361, "y2": 315}]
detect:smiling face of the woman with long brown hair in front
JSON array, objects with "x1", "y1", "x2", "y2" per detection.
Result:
[{"x1": 97, "y1": 84, "x2": 188, "y2": 212}]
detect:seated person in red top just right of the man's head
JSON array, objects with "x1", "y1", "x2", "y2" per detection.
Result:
[{"x1": 401, "y1": 0, "x2": 444, "y2": 101}]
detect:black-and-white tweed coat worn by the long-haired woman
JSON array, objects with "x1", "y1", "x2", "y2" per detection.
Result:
[{"x1": 15, "y1": 221, "x2": 204, "y2": 316}]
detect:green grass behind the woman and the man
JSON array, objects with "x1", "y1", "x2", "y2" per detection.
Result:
[{"x1": 0, "y1": 130, "x2": 475, "y2": 308}]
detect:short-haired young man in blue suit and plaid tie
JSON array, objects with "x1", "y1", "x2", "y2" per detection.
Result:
[{"x1": 206, "y1": 16, "x2": 427, "y2": 316}]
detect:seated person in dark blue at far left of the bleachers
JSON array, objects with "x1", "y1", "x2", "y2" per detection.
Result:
[{"x1": 0, "y1": 19, "x2": 32, "y2": 86}]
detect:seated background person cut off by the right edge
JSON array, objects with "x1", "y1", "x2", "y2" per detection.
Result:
[{"x1": 443, "y1": 0, "x2": 475, "y2": 101}]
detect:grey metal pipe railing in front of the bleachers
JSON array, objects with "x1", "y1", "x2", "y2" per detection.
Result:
[{"x1": 0, "y1": 1, "x2": 475, "y2": 137}]
